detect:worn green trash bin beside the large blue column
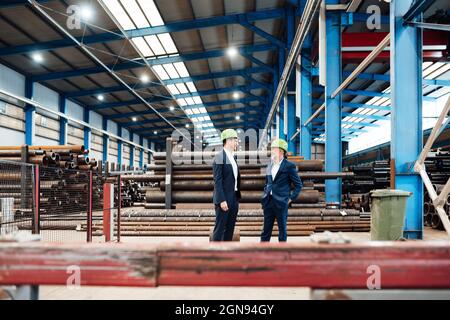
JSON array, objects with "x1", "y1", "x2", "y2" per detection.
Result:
[{"x1": 370, "y1": 189, "x2": 412, "y2": 241}]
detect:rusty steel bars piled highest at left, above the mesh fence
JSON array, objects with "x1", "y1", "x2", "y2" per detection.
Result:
[{"x1": 0, "y1": 145, "x2": 97, "y2": 170}]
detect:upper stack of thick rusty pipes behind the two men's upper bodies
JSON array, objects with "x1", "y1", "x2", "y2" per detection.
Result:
[{"x1": 134, "y1": 152, "x2": 352, "y2": 209}]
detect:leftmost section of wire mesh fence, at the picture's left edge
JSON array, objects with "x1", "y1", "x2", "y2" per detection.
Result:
[{"x1": 0, "y1": 161, "x2": 37, "y2": 236}]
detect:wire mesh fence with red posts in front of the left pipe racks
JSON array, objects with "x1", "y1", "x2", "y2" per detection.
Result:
[{"x1": 0, "y1": 161, "x2": 121, "y2": 242}]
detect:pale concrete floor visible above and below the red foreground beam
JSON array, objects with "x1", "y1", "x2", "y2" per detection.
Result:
[{"x1": 36, "y1": 228, "x2": 448, "y2": 300}]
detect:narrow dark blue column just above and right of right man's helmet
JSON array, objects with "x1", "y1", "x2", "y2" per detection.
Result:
[{"x1": 286, "y1": 7, "x2": 297, "y2": 155}]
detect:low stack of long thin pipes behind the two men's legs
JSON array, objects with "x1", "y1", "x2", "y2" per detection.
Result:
[{"x1": 79, "y1": 209, "x2": 370, "y2": 236}]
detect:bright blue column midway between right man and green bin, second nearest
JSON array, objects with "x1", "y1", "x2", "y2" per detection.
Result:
[{"x1": 325, "y1": 0, "x2": 342, "y2": 204}]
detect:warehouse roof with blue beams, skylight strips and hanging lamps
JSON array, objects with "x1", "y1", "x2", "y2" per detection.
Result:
[{"x1": 0, "y1": 0, "x2": 450, "y2": 150}]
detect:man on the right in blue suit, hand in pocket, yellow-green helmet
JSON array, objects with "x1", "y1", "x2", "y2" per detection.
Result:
[{"x1": 261, "y1": 139, "x2": 302, "y2": 242}]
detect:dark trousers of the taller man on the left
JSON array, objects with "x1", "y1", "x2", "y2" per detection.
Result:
[{"x1": 212, "y1": 193, "x2": 239, "y2": 241}]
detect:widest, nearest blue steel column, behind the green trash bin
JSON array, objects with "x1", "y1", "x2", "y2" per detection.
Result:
[{"x1": 390, "y1": 0, "x2": 423, "y2": 239}]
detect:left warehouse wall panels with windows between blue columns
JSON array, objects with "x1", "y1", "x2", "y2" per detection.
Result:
[{"x1": 0, "y1": 64, "x2": 148, "y2": 167}]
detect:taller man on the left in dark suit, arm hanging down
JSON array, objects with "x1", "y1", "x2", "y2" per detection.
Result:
[{"x1": 212, "y1": 129, "x2": 241, "y2": 241}]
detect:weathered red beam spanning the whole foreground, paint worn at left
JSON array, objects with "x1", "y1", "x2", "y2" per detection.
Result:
[{"x1": 0, "y1": 242, "x2": 450, "y2": 289}]
